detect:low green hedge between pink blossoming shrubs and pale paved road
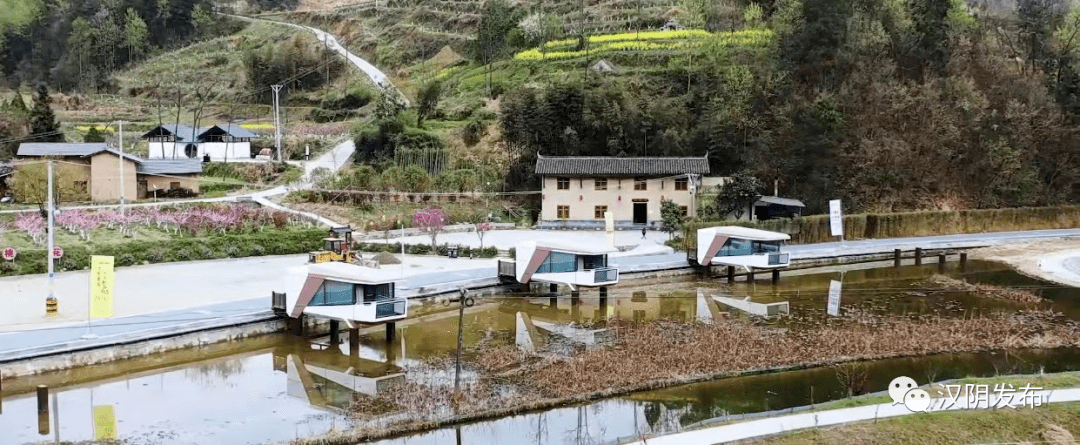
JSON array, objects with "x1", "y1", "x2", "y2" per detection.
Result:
[{"x1": 0, "y1": 228, "x2": 326, "y2": 275}]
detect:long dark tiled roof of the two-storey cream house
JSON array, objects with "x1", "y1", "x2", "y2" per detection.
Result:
[{"x1": 536, "y1": 156, "x2": 708, "y2": 176}]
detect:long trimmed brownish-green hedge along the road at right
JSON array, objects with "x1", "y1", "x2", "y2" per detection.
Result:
[{"x1": 684, "y1": 205, "x2": 1080, "y2": 248}]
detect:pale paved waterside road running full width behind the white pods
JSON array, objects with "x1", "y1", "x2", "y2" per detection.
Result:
[{"x1": 0, "y1": 227, "x2": 1080, "y2": 369}]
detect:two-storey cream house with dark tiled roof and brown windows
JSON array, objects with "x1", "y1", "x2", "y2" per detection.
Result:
[{"x1": 536, "y1": 156, "x2": 719, "y2": 229}]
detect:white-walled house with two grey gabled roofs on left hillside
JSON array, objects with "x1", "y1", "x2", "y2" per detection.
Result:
[{"x1": 143, "y1": 124, "x2": 258, "y2": 161}]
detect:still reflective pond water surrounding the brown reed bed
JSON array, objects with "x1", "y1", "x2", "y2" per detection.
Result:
[{"x1": 0, "y1": 261, "x2": 1080, "y2": 445}]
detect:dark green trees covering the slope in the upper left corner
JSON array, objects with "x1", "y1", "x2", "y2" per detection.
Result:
[{"x1": 0, "y1": 0, "x2": 240, "y2": 91}]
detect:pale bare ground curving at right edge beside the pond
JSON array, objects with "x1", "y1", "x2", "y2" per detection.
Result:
[{"x1": 971, "y1": 240, "x2": 1080, "y2": 287}]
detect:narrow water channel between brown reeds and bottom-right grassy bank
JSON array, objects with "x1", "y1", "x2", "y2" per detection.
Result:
[{"x1": 376, "y1": 349, "x2": 1080, "y2": 445}]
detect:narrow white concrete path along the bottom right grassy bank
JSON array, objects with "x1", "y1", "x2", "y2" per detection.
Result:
[{"x1": 632, "y1": 388, "x2": 1080, "y2": 445}]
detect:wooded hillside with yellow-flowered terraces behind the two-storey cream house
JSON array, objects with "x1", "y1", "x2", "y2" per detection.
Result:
[{"x1": 279, "y1": 0, "x2": 1080, "y2": 216}]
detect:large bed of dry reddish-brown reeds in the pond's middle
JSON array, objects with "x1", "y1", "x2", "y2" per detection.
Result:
[{"x1": 326, "y1": 311, "x2": 1080, "y2": 441}]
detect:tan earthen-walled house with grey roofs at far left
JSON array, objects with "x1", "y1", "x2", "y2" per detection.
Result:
[{"x1": 14, "y1": 143, "x2": 202, "y2": 202}]
